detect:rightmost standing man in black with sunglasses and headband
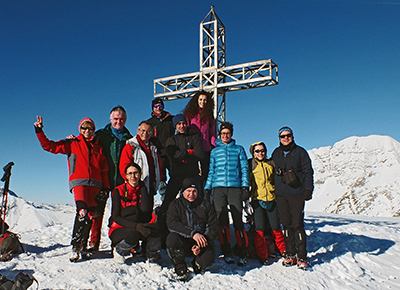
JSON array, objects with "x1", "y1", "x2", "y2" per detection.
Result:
[{"x1": 272, "y1": 127, "x2": 314, "y2": 270}]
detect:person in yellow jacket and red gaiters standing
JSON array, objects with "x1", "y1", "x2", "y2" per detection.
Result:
[{"x1": 249, "y1": 142, "x2": 286, "y2": 265}]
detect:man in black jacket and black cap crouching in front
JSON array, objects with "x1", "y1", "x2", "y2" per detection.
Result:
[{"x1": 166, "y1": 178, "x2": 218, "y2": 279}]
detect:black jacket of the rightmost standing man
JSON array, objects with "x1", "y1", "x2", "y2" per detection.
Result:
[{"x1": 272, "y1": 142, "x2": 314, "y2": 195}]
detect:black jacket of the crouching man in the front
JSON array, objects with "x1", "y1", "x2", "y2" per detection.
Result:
[{"x1": 167, "y1": 195, "x2": 218, "y2": 244}]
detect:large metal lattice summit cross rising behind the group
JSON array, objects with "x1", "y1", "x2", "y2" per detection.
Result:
[{"x1": 154, "y1": 6, "x2": 278, "y2": 127}]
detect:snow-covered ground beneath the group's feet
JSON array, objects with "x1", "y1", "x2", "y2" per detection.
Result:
[{"x1": 0, "y1": 195, "x2": 400, "y2": 290}]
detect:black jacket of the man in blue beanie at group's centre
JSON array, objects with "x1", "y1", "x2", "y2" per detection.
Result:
[{"x1": 166, "y1": 128, "x2": 204, "y2": 177}]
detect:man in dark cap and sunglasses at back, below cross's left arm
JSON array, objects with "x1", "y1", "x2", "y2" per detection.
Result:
[{"x1": 147, "y1": 98, "x2": 175, "y2": 182}]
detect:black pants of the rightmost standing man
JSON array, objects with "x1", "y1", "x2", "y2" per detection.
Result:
[{"x1": 276, "y1": 195, "x2": 307, "y2": 260}]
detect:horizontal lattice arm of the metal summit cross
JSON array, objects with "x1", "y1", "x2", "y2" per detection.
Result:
[{"x1": 154, "y1": 59, "x2": 278, "y2": 100}]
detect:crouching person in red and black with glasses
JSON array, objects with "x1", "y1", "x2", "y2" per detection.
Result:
[{"x1": 108, "y1": 162, "x2": 161, "y2": 264}]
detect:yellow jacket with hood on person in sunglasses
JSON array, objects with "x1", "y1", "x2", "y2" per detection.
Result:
[{"x1": 249, "y1": 142, "x2": 275, "y2": 201}]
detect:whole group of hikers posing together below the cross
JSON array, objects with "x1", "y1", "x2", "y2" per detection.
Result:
[{"x1": 34, "y1": 91, "x2": 313, "y2": 277}]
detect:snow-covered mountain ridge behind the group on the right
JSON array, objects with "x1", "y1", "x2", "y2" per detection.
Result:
[{"x1": 306, "y1": 135, "x2": 400, "y2": 217}]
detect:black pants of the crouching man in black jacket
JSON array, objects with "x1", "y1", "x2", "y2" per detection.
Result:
[{"x1": 166, "y1": 233, "x2": 216, "y2": 269}]
